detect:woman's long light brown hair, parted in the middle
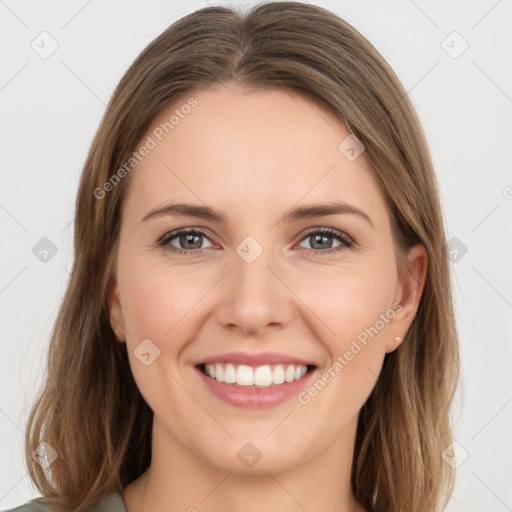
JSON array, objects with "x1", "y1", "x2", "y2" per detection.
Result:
[{"x1": 26, "y1": 1, "x2": 459, "y2": 512}]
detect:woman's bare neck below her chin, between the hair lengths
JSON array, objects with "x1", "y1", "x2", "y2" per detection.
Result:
[{"x1": 123, "y1": 417, "x2": 365, "y2": 512}]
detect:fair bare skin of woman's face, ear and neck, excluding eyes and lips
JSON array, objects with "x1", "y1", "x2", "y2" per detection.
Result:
[{"x1": 109, "y1": 85, "x2": 427, "y2": 512}]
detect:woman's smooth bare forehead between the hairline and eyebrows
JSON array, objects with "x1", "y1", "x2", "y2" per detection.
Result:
[{"x1": 125, "y1": 86, "x2": 385, "y2": 228}]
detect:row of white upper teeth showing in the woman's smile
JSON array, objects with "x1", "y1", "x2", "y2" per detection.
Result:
[{"x1": 205, "y1": 363, "x2": 307, "y2": 388}]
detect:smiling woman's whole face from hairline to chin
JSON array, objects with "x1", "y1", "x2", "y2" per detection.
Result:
[{"x1": 107, "y1": 86, "x2": 426, "y2": 472}]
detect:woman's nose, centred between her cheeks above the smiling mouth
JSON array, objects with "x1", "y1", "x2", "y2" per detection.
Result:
[{"x1": 216, "y1": 241, "x2": 294, "y2": 335}]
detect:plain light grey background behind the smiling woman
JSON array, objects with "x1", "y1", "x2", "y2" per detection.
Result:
[{"x1": 0, "y1": 0, "x2": 512, "y2": 512}]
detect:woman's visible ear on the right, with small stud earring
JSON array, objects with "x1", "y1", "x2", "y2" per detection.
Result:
[{"x1": 386, "y1": 244, "x2": 428, "y2": 353}]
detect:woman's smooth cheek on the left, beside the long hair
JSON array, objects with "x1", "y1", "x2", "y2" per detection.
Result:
[{"x1": 118, "y1": 253, "x2": 205, "y2": 416}]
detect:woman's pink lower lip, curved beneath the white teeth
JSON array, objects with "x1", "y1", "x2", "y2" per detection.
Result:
[{"x1": 195, "y1": 367, "x2": 316, "y2": 409}]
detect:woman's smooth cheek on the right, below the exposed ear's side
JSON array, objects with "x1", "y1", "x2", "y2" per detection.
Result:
[{"x1": 288, "y1": 255, "x2": 396, "y2": 398}]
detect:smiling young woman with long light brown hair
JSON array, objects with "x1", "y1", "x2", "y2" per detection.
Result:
[{"x1": 9, "y1": 2, "x2": 459, "y2": 512}]
